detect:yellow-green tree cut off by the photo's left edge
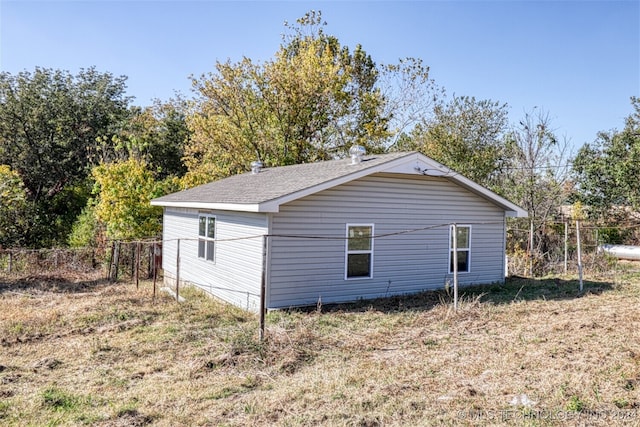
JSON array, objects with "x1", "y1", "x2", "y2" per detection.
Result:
[{"x1": 0, "y1": 165, "x2": 28, "y2": 247}]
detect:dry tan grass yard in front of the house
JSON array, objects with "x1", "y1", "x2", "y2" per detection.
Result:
[{"x1": 0, "y1": 272, "x2": 640, "y2": 426}]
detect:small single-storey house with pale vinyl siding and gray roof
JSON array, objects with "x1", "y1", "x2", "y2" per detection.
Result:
[{"x1": 151, "y1": 150, "x2": 527, "y2": 311}]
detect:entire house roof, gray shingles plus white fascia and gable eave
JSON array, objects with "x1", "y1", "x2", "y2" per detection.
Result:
[{"x1": 151, "y1": 152, "x2": 527, "y2": 217}]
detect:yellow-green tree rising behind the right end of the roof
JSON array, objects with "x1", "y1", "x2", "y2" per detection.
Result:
[{"x1": 397, "y1": 96, "x2": 508, "y2": 190}]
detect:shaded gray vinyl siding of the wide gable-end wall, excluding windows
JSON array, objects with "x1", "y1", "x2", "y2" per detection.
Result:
[{"x1": 267, "y1": 174, "x2": 505, "y2": 308}]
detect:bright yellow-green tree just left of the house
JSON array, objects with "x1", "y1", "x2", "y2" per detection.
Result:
[{"x1": 92, "y1": 158, "x2": 165, "y2": 239}]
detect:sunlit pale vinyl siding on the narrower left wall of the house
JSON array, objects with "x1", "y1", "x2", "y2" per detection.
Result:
[{"x1": 162, "y1": 208, "x2": 268, "y2": 311}]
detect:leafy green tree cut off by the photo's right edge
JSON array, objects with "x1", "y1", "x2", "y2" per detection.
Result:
[{"x1": 573, "y1": 97, "x2": 640, "y2": 218}]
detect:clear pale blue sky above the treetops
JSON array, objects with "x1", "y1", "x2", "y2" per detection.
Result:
[{"x1": 0, "y1": 0, "x2": 640, "y2": 150}]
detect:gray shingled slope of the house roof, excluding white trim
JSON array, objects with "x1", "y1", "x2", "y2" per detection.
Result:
[{"x1": 153, "y1": 152, "x2": 415, "y2": 205}]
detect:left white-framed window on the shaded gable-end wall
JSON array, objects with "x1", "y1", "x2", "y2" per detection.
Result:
[{"x1": 345, "y1": 224, "x2": 373, "y2": 279}]
